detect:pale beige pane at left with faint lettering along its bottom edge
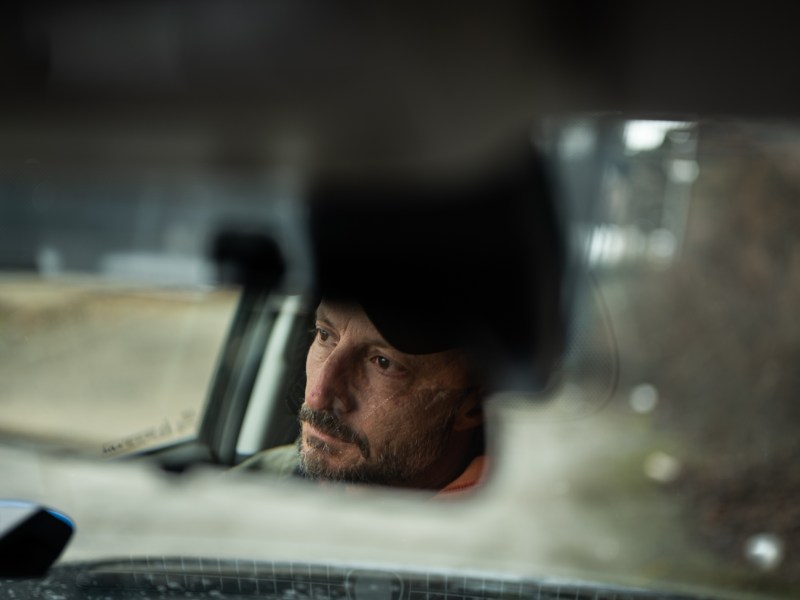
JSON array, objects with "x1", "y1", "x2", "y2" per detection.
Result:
[{"x1": 0, "y1": 274, "x2": 238, "y2": 456}]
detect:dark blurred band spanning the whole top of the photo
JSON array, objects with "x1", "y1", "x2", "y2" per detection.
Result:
[{"x1": 0, "y1": 0, "x2": 800, "y2": 175}]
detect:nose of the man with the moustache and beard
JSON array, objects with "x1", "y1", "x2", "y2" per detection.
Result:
[{"x1": 305, "y1": 347, "x2": 354, "y2": 414}]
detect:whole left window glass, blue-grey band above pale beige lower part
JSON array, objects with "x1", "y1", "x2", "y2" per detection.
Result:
[{"x1": 0, "y1": 172, "x2": 275, "y2": 457}]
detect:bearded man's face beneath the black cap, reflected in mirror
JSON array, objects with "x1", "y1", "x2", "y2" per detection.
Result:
[{"x1": 298, "y1": 301, "x2": 481, "y2": 488}]
